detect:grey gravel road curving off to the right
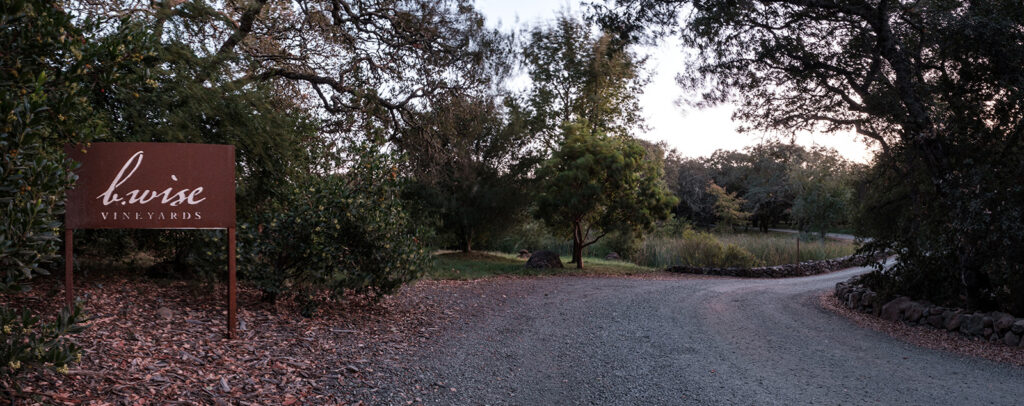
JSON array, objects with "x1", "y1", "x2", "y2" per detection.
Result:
[{"x1": 380, "y1": 269, "x2": 1024, "y2": 405}]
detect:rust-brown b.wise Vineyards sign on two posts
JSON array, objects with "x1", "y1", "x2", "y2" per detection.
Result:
[{"x1": 65, "y1": 143, "x2": 238, "y2": 338}]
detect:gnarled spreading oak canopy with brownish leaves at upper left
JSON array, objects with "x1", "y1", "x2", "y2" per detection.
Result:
[{"x1": 75, "y1": 0, "x2": 508, "y2": 144}]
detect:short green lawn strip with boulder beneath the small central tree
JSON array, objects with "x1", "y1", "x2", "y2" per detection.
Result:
[{"x1": 426, "y1": 251, "x2": 655, "y2": 280}]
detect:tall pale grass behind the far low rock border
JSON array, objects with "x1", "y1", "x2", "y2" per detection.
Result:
[{"x1": 632, "y1": 230, "x2": 857, "y2": 268}]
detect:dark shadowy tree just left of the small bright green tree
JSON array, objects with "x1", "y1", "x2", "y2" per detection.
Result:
[{"x1": 407, "y1": 94, "x2": 540, "y2": 252}]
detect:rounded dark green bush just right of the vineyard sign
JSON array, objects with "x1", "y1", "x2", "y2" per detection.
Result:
[{"x1": 239, "y1": 147, "x2": 427, "y2": 309}]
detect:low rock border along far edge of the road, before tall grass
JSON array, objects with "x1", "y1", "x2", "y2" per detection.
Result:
[{"x1": 665, "y1": 254, "x2": 881, "y2": 278}]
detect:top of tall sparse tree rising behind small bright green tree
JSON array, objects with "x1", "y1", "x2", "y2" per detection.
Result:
[{"x1": 522, "y1": 15, "x2": 646, "y2": 149}]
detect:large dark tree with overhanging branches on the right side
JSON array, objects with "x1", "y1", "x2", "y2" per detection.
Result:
[{"x1": 596, "y1": 0, "x2": 1024, "y2": 313}]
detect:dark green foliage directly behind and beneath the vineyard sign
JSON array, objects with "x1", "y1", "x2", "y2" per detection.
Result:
[{"x1": 72, "y1": 15, "x2": 330, "y2": 279}]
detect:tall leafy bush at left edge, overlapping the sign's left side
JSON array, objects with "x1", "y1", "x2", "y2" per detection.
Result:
[{"x1": 0, "y1": 0, "x2": 102, "y2": 291}]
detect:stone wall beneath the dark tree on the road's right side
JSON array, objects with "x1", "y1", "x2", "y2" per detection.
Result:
[{"x1": 836, "y1": 276, "x2": 1024, "y2": 347}]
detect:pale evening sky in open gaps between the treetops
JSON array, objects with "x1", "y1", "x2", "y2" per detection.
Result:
[{"x1": 476, "y1": 0, "x2": 873, "y2": 162}]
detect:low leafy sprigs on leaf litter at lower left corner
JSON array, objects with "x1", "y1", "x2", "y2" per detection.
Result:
[{"x1": 0, "y1": 307, "x2": 85, "y2": 391}]
